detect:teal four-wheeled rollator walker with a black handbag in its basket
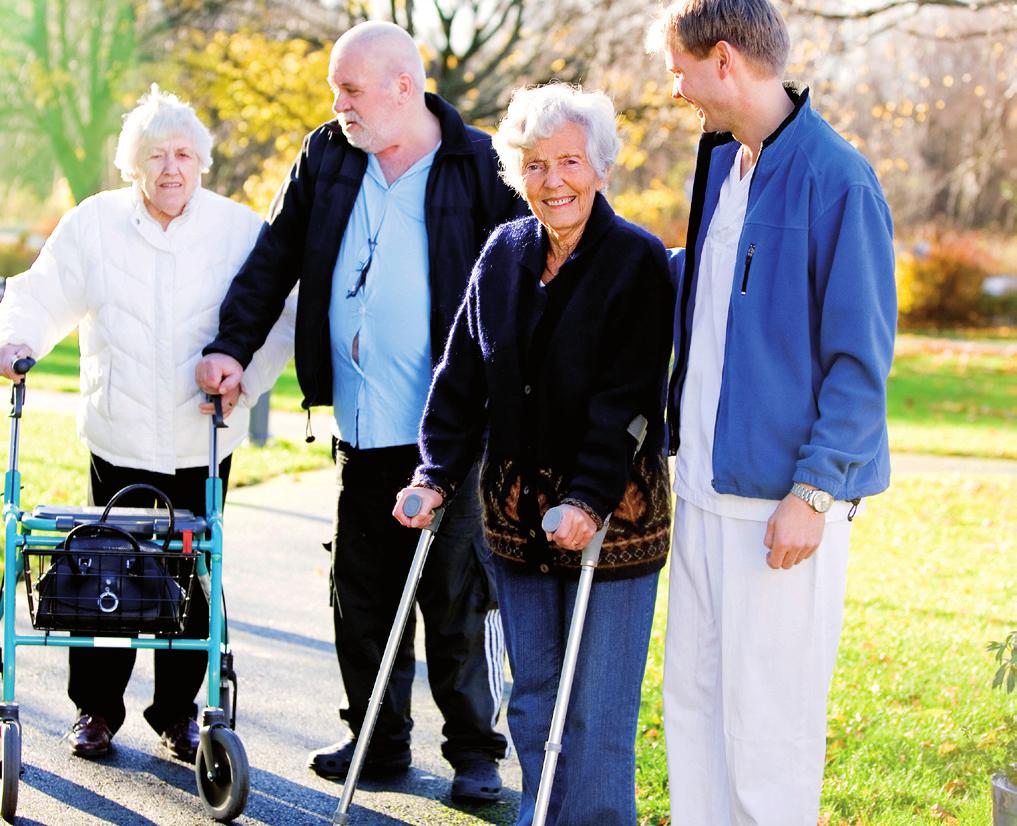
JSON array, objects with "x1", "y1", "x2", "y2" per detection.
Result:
[{"x1": 0, "y1": 358, "x2": 250, "y2": 823}]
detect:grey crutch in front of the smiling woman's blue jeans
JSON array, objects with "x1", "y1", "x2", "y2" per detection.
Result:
[{"x1": 533, "y1": 415, "x2": 647, "y2": 826}]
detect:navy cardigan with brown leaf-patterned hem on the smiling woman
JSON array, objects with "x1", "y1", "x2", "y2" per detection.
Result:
[{"x1": 415, "y1": 193, "x2": 674, "y2": 578}]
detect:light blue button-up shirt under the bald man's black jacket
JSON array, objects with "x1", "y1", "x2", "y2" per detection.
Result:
[{"x1": 328, "y1": 146, "x2": 437, "y2": 450}]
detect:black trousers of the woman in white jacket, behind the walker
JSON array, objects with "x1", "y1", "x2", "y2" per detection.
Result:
[{"x1": 67, "y1": 454, "x2": 232, "y2": 732}]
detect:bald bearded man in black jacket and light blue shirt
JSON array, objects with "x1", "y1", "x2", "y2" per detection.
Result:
[{"x1": 197, "y1": 22, "x2": 524, "y2": 802}]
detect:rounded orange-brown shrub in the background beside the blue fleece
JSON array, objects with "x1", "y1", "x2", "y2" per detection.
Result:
[{"x1": 897, "y1": 232, "x2": 993, "y2": 327}]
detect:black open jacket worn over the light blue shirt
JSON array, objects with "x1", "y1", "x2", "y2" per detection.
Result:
[{"x1": 202, "y1": 94, "x2": 525, "y2": 408}]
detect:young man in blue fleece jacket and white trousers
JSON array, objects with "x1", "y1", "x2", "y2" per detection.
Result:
[{"x1": 657, "y1": 0, "x2": 896, "y2": 826}]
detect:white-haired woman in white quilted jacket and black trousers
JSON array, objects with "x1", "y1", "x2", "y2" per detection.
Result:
[{"x1": 0, "y1": 85, "x2": 294, "y2": 763}]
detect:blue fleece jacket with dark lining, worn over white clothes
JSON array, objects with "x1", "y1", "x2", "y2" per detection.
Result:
[{"x1": 668, "y1": 86, "x2": 897, "y2": 499}]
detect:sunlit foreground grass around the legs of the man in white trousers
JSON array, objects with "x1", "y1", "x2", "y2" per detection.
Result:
[{"x1": 637, "y1": 474, "x2": 1017, "y2": 826}]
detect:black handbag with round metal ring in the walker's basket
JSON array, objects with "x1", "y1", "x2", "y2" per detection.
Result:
[{"x1": 33, "y1": 485, "x2": 194, "y2": 636}]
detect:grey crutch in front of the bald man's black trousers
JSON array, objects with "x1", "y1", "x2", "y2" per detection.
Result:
[{"x1": 332, "y1": 493, "x2": 444, "y2": 824}]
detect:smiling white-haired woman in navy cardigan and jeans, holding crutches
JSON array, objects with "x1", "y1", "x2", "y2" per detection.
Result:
[{"x1": 393, "y1": 83, "x2": 674, "y2": 826}]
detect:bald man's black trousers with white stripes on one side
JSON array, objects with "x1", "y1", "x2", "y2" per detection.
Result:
[{"x1": 332, "y1": 443, "x2": 506, "y2": 766}]
